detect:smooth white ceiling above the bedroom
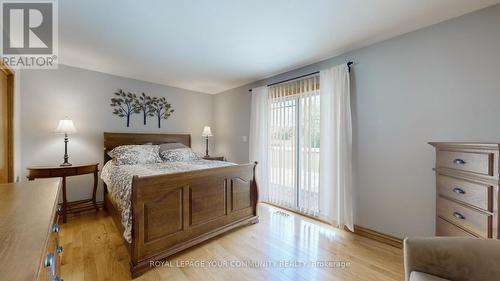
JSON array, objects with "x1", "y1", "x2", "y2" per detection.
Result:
[{"x1": 59, "y1": 0, "x2": 500, "y2": 93}]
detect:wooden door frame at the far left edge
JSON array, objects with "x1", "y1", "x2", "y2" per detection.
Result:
[{"x1": 0, "y1": 62, "x2": 14, "y2": 182}]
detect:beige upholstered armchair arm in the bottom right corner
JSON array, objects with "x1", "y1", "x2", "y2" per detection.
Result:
[{"x1": 404, "y1": 237, "x2": 500, "y2": 281}]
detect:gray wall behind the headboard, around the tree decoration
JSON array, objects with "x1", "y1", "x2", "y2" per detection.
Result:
[{"x1": 20, "y1": 65, "x2": 213, "y2": 200}]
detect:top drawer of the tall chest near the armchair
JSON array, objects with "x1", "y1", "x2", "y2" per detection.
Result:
[{"x1": 436, "y1": 150, "x2": 494, "y2": 176}]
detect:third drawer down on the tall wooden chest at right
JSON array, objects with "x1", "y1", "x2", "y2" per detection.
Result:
[{"x1": 437, "y1": 197, "x2": 493, "y2": 238}]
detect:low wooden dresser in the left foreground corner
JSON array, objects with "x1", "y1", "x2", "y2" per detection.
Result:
[{"x1": 0, "y1": 179, "x2": 62, "y2": 281}]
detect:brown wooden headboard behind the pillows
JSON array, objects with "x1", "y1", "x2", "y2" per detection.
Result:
[{"x1": 104, "y1": 132, "x2": 191, "y2": 164}]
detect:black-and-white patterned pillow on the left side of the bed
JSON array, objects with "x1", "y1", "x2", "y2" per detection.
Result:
[{"x1": 108, "y1": 145, "x2": 161, "y2": 165}]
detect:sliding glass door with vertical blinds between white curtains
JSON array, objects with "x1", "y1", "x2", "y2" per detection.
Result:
[{"x1": 269, "y1": 76, "x2": 320, "y2": 215}]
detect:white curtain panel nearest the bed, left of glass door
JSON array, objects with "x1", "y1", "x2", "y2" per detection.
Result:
[{"x1": 249, "y1": 86, "x2": 270, "y2": 201}]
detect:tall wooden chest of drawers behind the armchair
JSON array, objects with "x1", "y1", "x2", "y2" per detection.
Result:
[{"x1": 430, "y1": 142, "x2": 500, "y2": 239}]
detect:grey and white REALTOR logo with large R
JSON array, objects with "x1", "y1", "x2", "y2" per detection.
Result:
[{"x1": 1, "y1": 0, "x2": 57, "y2": 69}]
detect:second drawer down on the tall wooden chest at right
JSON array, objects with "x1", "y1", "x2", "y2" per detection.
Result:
[{"x1": 437, "y1": 175, "x2": 493, "y2": 212}]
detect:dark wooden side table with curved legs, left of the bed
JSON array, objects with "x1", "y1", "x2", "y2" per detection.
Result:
[{"x1": 27, "y1": 163, "x2": 99, "y2": 223}]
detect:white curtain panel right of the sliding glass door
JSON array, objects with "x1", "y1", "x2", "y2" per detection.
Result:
[{"x1": 319, "y1": 64, "x2": 354, "y2": 231}]
